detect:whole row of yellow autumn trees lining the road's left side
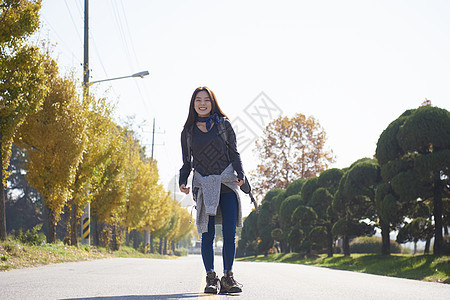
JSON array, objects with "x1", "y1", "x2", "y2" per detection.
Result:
[{"x1": 0, "y1": 0, "x2": 192, "y2": 253}]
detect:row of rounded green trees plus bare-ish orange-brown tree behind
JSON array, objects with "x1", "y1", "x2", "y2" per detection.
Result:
[{"x1": 243, "y1": 101, "x2": 450, "y2": 257}]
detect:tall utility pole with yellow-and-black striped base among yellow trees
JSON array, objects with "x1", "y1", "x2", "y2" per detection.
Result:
[{"x1": 81, "y1": 0, "x2": 91, "y2": 245}]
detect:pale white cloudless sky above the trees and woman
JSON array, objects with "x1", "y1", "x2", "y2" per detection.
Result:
[{"x1": 39, "y1": 0, "x2": 450, "y2": 216}]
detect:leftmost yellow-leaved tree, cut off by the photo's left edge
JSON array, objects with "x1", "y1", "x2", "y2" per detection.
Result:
[{"x1": 0, "y1": 0, "x2": 46, "y2": 240}]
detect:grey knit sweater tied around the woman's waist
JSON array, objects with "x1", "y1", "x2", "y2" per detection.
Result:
[{"x1": 192, "y1": 164, "x2": 242, "y2": 234}]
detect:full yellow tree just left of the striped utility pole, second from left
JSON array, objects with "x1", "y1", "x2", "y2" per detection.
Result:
[{"x1": 15, "y1": 57, "x2": 87, "y2": 243}]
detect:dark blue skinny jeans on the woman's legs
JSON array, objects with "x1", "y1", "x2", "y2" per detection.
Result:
[{"x1": 202, "y1": 192, "x2": 237, "y2": 274}]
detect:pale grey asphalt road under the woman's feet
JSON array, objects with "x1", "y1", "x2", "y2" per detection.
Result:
[{"x1": 0, "y1": 255, "x2": 450, "y2": 300}]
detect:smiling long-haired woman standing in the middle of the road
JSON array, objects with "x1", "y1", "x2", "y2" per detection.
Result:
[{"x1": 179, "y1": 87, "x2": 245, "y2": 294}]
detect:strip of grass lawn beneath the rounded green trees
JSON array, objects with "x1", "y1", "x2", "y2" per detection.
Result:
[{"x1": 237, "y1": 253, "x2": 450, "y2": 283}]
